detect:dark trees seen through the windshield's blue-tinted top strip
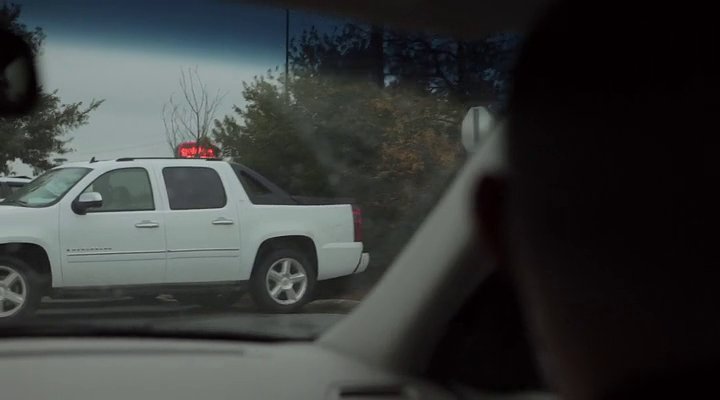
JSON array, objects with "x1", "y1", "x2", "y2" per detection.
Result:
[{"x1": 291, "y1": 24, "x2": 520, "y2": 109}]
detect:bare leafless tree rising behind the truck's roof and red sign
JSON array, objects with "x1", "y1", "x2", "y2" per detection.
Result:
[{"x1": 162, "y1": 67, "x2": 225, "y2": 153}]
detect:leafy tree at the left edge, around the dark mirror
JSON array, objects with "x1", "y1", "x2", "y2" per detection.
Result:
[{"x1": 0, "y1": 3, "x2": 103, "y2": 174}]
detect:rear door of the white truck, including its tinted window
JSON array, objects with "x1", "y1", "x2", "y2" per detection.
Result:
[{"x1": 162, "y1": 166, "x2": 240, "y2": 283}]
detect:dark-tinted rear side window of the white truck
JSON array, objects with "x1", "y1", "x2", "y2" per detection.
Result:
[{"x1": 163, "y1": 167, "x2": 227, "y2": 210}]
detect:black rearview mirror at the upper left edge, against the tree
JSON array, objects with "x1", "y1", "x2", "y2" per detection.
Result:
[{"x1": 0, "y1": 30, "x2": 39, "y2": 117}]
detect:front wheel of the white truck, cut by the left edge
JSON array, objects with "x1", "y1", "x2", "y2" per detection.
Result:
[{"x1": 0, "y1": 256, "x2": 44, "y2": 324}]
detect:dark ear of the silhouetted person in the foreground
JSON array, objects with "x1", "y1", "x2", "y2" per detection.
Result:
[{"x1": 475, "y1": 175, "x2": 507, "y2": 266}]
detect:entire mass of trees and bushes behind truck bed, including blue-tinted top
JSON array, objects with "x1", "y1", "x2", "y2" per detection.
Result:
[{"x1": 214, "y1": 24, "x2": 512, "y2": 280}]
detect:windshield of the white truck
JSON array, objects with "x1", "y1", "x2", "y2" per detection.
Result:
[{"x1": 0, "y1": 168, "x2": 90, "y2": 207}]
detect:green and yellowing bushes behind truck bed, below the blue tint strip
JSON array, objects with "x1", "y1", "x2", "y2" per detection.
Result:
[{"x1": 214, "y1": 73, "x2": 463, "y2": 280}]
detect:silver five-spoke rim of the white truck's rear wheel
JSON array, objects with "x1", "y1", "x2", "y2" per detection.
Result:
[{"x1": 265, "y1": 258, "x2": 308, "y2": 306}]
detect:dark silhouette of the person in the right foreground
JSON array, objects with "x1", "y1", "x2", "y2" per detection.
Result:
[{"x1": 478, "y1": 0, "x2": 720, "y2": 399}]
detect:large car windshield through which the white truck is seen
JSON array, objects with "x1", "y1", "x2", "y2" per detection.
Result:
[{"x1": 0, "y1": 0, "x2": 521, "y2": 339}]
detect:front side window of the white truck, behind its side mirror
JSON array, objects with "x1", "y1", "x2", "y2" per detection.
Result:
[{"x1": 83, "y1": 168, "x2": 155, "y2": 213}]
